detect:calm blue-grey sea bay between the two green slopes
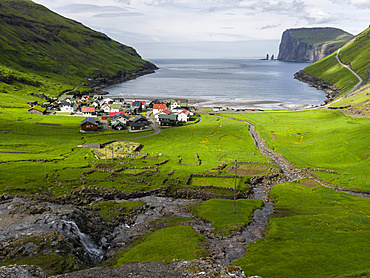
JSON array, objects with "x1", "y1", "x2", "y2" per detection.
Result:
[{"x1": 105, "y1": 59, "x2": 326, "y2": 109}]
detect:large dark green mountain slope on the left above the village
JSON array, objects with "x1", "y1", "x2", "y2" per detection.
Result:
[{"x1": 0, "y1": 0, "x2": 156, "y2": 106}]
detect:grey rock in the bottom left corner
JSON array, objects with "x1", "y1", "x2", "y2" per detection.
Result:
[{"x1": 0, "y1": 265, "x2": 46, "y2": 278}]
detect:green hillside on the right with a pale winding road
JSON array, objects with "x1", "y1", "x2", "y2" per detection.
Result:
[{"x1": 296, "y1": 28, "x2": 370, "y2": 116}]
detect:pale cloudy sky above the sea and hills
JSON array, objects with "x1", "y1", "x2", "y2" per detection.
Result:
[{"x1": 33, "y1": 0, "x2": 370, "y2": 59}]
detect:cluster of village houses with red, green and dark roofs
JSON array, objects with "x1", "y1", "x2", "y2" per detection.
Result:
[{"x1": 27, "y1": 93, "x2": 194, "y2": 132}]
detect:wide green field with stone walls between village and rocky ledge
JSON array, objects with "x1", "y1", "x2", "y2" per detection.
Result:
[{"x1": 0, "y1": 108, "x2": 268, "y2": 196}]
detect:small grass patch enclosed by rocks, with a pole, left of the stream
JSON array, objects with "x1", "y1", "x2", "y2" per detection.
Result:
[{"x1": 193, "y1": 199, "x2": 263, "y2": 235}]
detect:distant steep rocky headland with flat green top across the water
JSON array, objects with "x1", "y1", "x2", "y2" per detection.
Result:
[{"x1": 278, "y1": 28, "x2": 353, "y2": 62}]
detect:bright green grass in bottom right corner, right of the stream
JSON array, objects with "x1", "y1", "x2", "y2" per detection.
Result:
[{"x1": 235, "y1": 183, "x2": 370, "y2": 278}]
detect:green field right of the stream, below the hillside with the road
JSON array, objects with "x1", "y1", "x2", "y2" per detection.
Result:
[{"x1": 222, "y1": 110, "x2": 370, "y2": 191}]
